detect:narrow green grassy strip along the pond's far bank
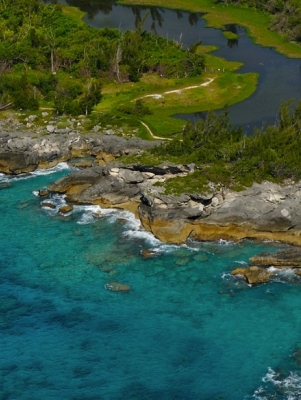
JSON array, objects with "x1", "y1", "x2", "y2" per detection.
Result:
[{"x1": 120, "y1": 0, "x2": 301, "y2": 58}]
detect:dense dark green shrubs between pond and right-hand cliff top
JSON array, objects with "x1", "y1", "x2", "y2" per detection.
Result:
[{"x1": 152, "y1": 102, "x2": 301, "y2": 190}]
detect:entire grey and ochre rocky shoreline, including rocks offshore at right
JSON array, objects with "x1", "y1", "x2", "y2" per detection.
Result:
[{"x1": 0, "y1": 120, "x2": 301, "y2": 283}]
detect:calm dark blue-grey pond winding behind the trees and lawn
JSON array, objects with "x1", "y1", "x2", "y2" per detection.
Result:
[{"x1": 53, "y1": 0, "x2": 301, "y2": 131}]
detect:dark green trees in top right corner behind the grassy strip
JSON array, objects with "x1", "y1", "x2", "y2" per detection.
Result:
[{"x1": 217, "y1": 0, "x2": 301, "y2": 42}]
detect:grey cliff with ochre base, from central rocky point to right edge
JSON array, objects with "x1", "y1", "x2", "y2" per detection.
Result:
[{"x1": 44, "y1": 163, "x2": 301, "y2": 245}]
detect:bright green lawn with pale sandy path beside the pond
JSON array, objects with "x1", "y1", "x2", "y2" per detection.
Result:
[{"x1": 96, "y1": 46, "x2": 258, "y2": 138}]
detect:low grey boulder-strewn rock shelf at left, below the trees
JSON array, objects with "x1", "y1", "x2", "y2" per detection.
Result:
[{"x1": 0, "y1": 132, "x2": 154, "y2": 175}]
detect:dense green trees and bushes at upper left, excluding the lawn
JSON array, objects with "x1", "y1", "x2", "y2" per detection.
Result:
[{"x1": 0, "y1": 0, "x2": 204, "y2": 114}]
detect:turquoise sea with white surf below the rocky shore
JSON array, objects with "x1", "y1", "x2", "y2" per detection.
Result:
[{"x1": 0, "y1": 164, "x2": 301, "y2": 400}]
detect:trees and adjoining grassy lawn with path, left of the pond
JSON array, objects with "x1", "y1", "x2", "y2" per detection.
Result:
[{"x1": 0, "y1": 0, "x2": 257, "y2": 139}]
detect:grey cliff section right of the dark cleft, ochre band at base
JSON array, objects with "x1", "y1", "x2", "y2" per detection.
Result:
[{"x1": 139, "y1": 182, "x2": 301, "y2": 245}]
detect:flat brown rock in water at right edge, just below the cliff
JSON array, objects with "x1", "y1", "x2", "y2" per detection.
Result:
[{"x1": 250, "y1": 247, "x2": 301, "y2": 268}]
